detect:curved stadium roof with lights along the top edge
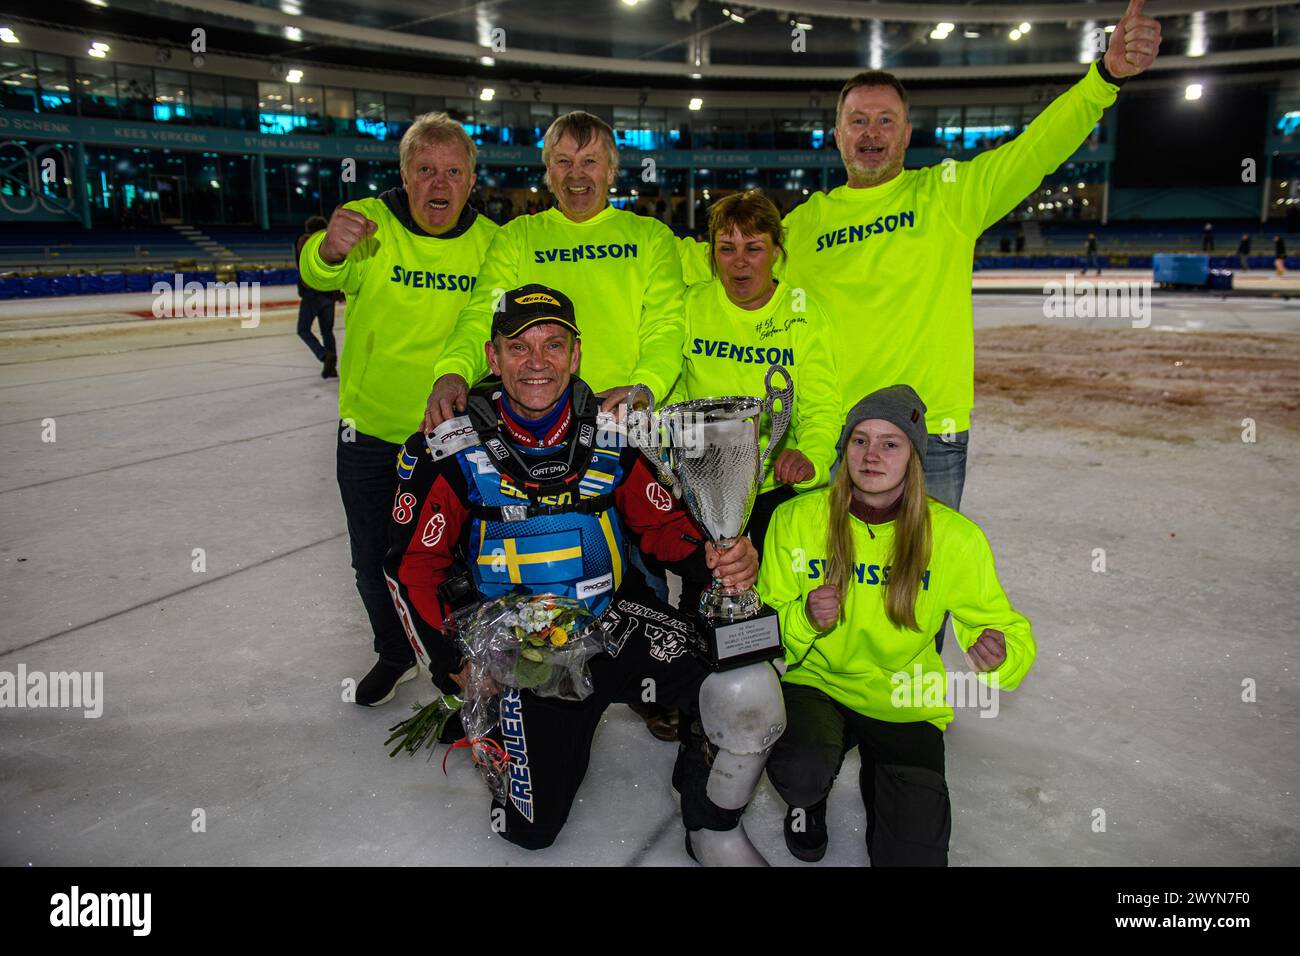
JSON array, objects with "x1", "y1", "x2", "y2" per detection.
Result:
[{"x1": 10, "y1": 0, "x2": 1300, "y2": 87}]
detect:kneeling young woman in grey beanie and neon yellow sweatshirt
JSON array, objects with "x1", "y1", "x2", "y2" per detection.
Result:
[{"x1": 758, "y1": 385, "x2": 1036, "y2": 866}]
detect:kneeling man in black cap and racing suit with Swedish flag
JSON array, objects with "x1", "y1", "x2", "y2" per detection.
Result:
[{"x1": 384, "y1": 284, "x2": 785, "y2": 865}]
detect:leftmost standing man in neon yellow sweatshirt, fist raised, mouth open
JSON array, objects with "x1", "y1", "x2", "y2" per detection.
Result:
[{"x1": 299, "y1": 113, "x2": 498, "y2": 706}]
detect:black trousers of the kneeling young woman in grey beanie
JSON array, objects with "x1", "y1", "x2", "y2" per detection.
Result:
[{"x1": 767, "y1": 682, "x2": 953, "y2": 866}]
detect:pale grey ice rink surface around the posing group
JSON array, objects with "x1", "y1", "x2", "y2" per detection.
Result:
[{"x1": 0, "y1": 294, "x2": 1300, "y2": 866}]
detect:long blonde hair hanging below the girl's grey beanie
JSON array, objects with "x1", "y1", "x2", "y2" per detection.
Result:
[{"x1": 826, "y1": 445, "x2": 933, "y2": 631}]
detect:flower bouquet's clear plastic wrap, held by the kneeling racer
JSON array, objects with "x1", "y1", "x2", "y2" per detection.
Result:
[{"x1": 456, "y1": 594, "x2": 603, "y2": 803}]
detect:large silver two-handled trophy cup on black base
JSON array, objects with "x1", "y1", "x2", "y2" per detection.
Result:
[{"x1": 628, "y1": 365, "x2": 794, "y2": 667}]
